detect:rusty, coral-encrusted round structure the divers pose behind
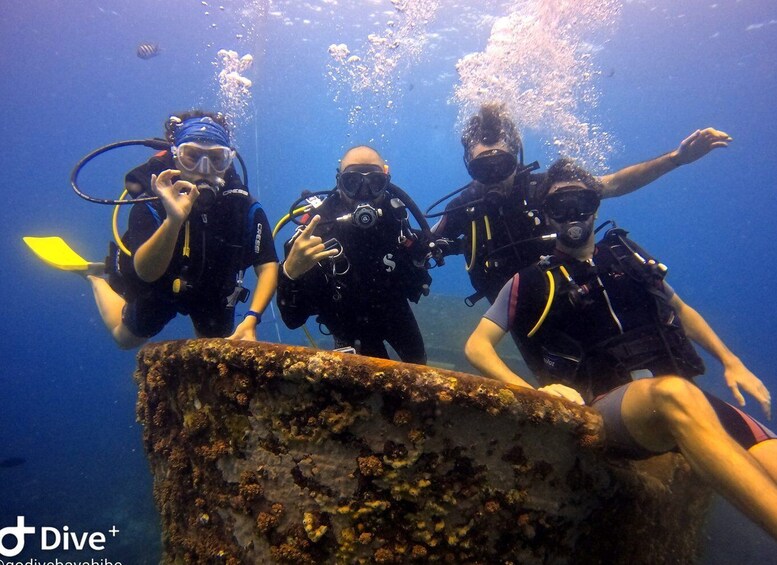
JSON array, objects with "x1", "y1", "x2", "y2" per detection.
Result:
[{"x1": 136, "y1": 339, "x2": 709, "y2": 564}]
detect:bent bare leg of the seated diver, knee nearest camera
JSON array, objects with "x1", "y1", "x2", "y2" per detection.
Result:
[{"x1": 621, "y1": 377, "x2": 777, "y2": 539}]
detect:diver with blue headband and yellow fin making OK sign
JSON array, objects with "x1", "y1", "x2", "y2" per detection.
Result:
[{"x1": 25, "y1": 110, "x2": 278, "y2": 349}]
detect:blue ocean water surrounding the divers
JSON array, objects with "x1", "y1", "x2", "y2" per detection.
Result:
[{"x1": 0, "y1": 0, "x2": 777, "y2": 564}]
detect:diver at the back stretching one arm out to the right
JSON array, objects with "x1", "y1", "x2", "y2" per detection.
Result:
[{"x1": 426, "y1": 104, "x2": 732, "y2": 305}]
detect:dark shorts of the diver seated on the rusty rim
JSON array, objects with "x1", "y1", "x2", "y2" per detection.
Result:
[{"x1": 591, "y1": 383, "x2": 777, "y2": 458}]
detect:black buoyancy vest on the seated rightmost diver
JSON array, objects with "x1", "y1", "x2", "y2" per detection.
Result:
[{"x1": 511, "y1": 229, "x2": 704, "y2": 401}]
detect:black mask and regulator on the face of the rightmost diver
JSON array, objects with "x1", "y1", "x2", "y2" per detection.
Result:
[{"x1": 544, "y1": 186, "x2": 600, "y2": 248}]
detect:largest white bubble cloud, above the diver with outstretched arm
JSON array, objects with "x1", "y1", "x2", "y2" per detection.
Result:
[{"x1": 454, "y1": 0, "x2": 621, "y2": 170}]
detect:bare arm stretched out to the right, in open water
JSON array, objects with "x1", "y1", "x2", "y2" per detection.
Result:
[{"x1": 599, "y1": 128, "x2": 733, "y2": 198}]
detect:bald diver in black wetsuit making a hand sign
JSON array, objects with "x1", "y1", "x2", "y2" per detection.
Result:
[{"x1": 276, "y1": 146, "x2": 436, "y2": 364}]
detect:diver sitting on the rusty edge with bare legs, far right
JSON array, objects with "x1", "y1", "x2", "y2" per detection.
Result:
[{"x1": 465, "y1": 159, "x2": 777, "y2": 538}]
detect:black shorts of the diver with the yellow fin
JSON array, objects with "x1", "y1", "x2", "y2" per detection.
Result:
[{"x1": 121, "y1": 293, "x2": 235, "y2": 338}]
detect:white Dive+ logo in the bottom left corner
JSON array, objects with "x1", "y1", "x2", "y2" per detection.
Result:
[{"x1": 0, "y1": 516, "x2": 120, "y2": 557}]
